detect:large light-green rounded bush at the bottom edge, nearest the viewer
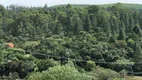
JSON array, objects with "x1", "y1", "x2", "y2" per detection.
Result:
[{"x1": 28, "y1": 66, "x2": 97, "y2": 80}]
